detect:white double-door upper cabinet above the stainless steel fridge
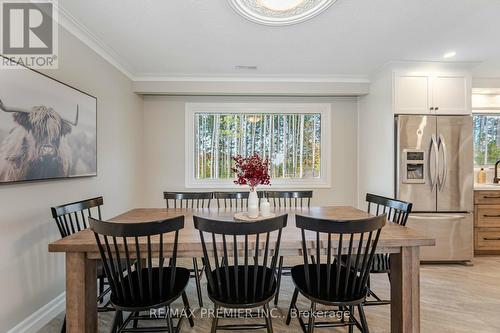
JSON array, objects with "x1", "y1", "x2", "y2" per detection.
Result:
[{"x1": 394, "y1": 72, "x2": 471, "y2": 114}]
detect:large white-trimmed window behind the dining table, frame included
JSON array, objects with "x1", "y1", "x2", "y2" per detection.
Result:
[{"x1": 186, "y1": 103, "x2": 330, "y2": 187}]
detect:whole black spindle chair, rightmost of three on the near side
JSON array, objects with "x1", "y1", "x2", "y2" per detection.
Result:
[{"x1": 286, "y1": 215, "x2": 387, "y2": 333}]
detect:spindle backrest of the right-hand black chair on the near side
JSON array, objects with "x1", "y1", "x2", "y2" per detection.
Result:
[{"x1": 295, "y1": 215, "x2": 386, "y2": 301}]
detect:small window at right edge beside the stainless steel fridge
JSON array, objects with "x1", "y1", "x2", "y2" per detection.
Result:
[{"x1": 473, "y1": 114, "x2": 500, "y2": 166}]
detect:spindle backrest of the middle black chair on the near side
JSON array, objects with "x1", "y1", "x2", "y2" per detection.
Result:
[{"x1": 193, "y1": 215, "x2": 288, "y2": 300}]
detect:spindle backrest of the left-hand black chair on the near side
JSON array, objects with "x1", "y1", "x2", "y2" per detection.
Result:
[{"x1": 89, "y1": 216, "x2": 184, "y2": 304}]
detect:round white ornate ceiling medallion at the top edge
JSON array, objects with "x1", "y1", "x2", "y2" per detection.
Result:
[{"x1": 229, "y1": 0, "x2": 336, "y2": 26}]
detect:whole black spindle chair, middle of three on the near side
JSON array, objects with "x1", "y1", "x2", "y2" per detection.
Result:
[{"x1": 194, "y1": 215, "x2": 288, "y2": 333}]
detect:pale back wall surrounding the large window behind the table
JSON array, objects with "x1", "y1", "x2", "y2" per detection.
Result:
[{"x1": 142, "y1": 96, "x2": 357, "y2": 207}]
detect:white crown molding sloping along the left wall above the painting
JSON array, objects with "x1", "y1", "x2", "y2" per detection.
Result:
[{"x1": 55, "y1": 2, "x2": 135, "y2": 81}]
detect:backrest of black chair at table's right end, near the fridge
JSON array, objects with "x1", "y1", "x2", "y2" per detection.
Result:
[{"x1": 366, "y1": 193, "x2": 413, "y2": 226}]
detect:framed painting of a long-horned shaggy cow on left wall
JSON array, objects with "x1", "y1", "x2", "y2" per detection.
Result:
[{"x1": 0, "y1": 58, "x2": 97, "y2": 184}]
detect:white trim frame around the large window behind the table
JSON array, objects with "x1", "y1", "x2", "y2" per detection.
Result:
[{"x1": 184, "y1": 103, "x2": 332, "y2": 189}]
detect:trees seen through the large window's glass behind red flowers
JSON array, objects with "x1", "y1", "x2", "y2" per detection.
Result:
[{"x1": 195, "y1": 113, "x2": 321, "y2": 179}]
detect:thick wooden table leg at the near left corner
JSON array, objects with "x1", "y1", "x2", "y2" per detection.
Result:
[{"x1": 66, "y1": 252, "x2": 97, "y2": 333}]
